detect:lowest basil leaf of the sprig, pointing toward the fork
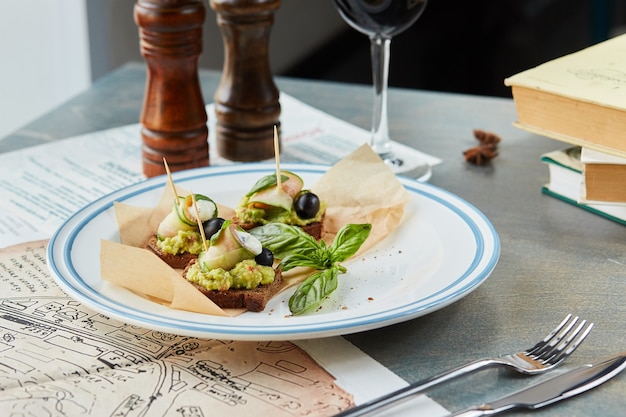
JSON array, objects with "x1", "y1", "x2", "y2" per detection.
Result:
[{"x1": 289, "y1": 268, "x2": 339, "y2": 315}]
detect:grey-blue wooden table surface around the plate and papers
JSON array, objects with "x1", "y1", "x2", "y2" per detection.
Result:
[{"x1": 0, "y1": 63, "x2": 626, "y2": 417}]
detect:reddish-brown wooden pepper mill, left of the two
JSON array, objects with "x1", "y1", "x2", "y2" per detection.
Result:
[{"x1": 134, "y1": 0, "x2": 209, "y2": 177}]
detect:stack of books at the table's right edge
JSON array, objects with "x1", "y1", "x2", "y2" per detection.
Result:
[{"x1": 504, "y1": 35, "x2": 626, "y2": 225}]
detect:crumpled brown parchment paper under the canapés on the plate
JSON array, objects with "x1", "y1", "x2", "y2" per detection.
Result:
[{"x1": 101, "y1": 145, "x2": 409, "y2": 316}]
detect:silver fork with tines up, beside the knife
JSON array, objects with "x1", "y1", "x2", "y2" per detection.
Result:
[{"x1": 335, "y1": 314, "x2": 593, "y2": 417}]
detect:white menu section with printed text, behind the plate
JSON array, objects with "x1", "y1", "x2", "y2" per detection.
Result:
[{"x1": 0, "y1": 94, "x2": 441, "y2": 248}]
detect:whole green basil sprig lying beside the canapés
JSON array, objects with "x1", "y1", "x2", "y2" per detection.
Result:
[{"x1": 250, "y1": 223, "x2": 372, "y2": 315}]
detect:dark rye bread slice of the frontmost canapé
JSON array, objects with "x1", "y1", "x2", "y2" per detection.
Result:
[{"x1": 183, "y1": 260, "x2": 283, "y2": 312}]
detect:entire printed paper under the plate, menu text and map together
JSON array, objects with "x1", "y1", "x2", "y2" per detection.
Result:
[{"x1": 0, "y1": 94, "x2": 447, "y2": 417}]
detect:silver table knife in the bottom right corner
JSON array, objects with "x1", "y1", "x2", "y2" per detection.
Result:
[{"x1": 452, "y1": 352, "x2": 626, "y2": 417}]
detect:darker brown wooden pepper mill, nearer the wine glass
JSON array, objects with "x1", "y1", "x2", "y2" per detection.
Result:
[{"x1": 210, "y1": 0, "x2": 280, "y2": 161}]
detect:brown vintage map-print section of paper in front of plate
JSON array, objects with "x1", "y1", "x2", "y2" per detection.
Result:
[{"x1": 0, "y1": 241, "x2": 446, "y2": 417}]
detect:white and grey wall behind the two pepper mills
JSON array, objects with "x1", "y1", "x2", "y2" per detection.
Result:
[{"x1": 0, "y1": 0, "x2": 346, "y2": 140}]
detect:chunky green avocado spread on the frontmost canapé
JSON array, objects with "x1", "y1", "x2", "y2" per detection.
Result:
[{"x1": 186, "y1": 259, "x2": 274, "y2": 291}]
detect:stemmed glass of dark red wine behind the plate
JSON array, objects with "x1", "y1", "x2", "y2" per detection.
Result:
[{"x1": 334, "y1": 0, "x2": 431, "y2": 179}]
